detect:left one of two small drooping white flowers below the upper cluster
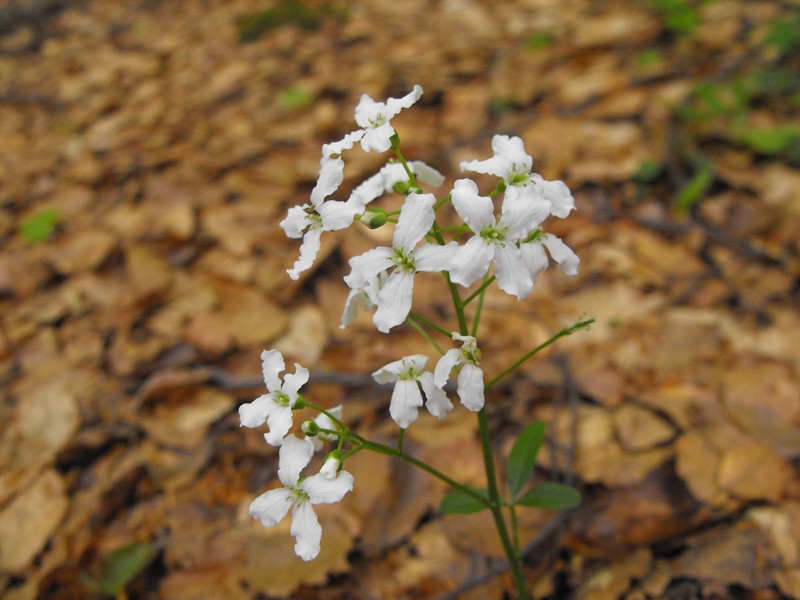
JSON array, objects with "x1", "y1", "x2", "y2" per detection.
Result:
[{"x1": 372, "y1": 354, "x2": 453, "y2": 429}]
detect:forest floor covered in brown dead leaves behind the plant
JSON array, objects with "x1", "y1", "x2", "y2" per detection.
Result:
[{"x1": 0, "y1": 0, "x2": 800, "y2": 600}]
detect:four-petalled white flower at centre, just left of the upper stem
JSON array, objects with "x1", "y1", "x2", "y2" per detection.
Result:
[{"x1": 344, "y1": 193, "x2": 456, "y2": 333}]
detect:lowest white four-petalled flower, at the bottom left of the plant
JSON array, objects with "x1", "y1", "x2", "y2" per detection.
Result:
[{"x1": 250, "y1": 435, "x2": 353, "y2": 560}]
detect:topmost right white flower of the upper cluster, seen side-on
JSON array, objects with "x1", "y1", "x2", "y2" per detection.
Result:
[{"x1": 461, "y1": 135, "x2": 575, "y2": 219}]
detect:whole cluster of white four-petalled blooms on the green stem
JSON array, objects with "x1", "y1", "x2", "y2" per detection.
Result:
[{"x1": 239, "y1": 86, "x2": 579, "y2": 560}]
